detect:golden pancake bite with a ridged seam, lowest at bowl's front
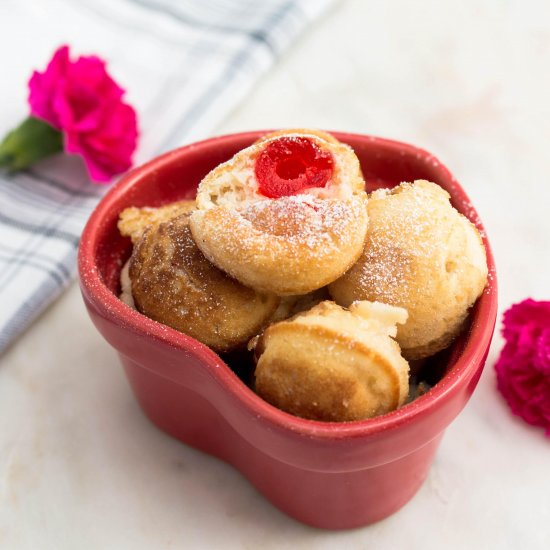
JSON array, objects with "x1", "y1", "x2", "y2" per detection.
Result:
[{"x1": 255, "y1": 301, "x2": 409, "y2": 422}]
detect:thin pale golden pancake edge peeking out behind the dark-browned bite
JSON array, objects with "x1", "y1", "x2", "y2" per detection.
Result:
[{"x1": 118, "y1": 200, "x2": 196, "y2": 244}]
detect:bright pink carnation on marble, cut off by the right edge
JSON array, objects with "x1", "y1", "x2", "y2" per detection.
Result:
[{"x1": 495, "y1": 299, "x2": 550, "y2": 437}]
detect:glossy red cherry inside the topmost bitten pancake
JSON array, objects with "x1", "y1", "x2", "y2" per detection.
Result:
[{"x1": 254, "y1": 137, "x2": 334, "y2": 199}]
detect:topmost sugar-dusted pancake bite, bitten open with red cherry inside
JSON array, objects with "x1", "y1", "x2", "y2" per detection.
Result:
[{"x1": 190, "y1": 130, "x2": 368, "y2": 296}]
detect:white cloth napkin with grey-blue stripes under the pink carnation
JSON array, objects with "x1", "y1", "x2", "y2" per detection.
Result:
[{"x1": 0, "y1": 0, "x2": 333, "y2": 353}]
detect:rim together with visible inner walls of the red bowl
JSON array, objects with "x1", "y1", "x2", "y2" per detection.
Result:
[{"x1": 79, "y1": 131, "x2": 497, "y2": 453}]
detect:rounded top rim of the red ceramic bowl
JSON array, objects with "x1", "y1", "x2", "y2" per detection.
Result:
[{"x1": 78, "y1": 130, "x2": 497, "y2": 439}]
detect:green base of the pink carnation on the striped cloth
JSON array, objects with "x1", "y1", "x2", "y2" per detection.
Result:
[{"x1": 0, "y1": 117, "x2": 63, "y2": 172}]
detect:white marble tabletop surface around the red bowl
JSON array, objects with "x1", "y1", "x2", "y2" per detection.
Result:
[{"x1": 0, "y1": 0, "x2": 550, "y2": 550}]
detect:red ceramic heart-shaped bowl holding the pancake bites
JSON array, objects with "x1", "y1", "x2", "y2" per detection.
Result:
[{"x1": 79, "y1": 132, "x2": 497, "y2": 529}]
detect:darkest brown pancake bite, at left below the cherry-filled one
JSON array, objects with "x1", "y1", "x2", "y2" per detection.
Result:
[{"x1": 126, "y1": 213, "x2": 279, "y2": 352}]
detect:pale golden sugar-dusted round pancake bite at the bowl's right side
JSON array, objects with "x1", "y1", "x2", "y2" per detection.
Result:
[{"x1": 329, "y1": 180, "x2": 487, "y2": 360}]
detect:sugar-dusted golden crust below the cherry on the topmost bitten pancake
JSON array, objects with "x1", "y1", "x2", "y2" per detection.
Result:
[{"x1": 191, "y1": 195, "x2": 368, "y2": 296}]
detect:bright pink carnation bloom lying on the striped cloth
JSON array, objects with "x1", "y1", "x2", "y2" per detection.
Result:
[{"x1": 29, "y1": 46, "x2": 138, "y2": 182}]
